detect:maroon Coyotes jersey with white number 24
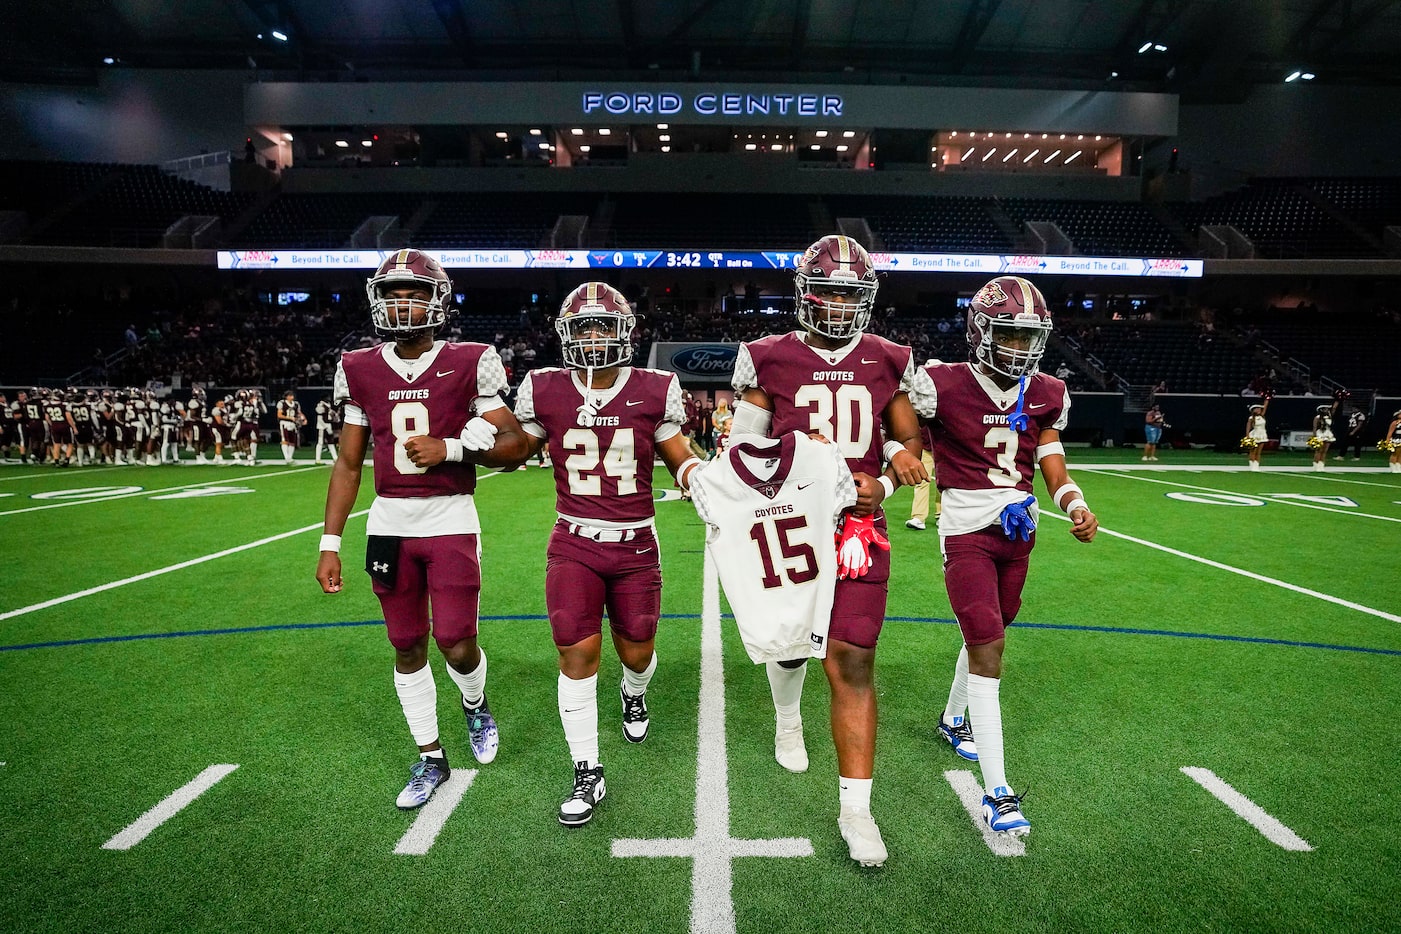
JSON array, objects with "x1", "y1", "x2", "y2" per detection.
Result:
[{"x1": 516, "y1": 367, "x2": 685, "y2": 524}]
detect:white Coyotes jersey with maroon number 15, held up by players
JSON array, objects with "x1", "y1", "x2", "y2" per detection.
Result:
[{"x1": 691, "y1": 431, "x2": 856, "y2": 664}]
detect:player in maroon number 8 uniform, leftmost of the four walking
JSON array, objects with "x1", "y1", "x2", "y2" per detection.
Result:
[{"x1": 317, "y1": 249, "x2": 525, "y2": 809}]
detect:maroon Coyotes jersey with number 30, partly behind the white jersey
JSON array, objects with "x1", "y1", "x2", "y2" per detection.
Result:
[{"x1": 734, "y1": 330, "x2": 913, "y2": 476}]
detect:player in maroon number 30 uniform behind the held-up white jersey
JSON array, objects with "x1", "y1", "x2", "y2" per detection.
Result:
[{"x1": 730, "y1": 234, "x2": 929, "y2": 865}]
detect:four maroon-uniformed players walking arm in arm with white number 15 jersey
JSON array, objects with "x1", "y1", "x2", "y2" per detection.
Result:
[{"x1": 317, "y1": 235, "x2": 1097, "y2": 865}]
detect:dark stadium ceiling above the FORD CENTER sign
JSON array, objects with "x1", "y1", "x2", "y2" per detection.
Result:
[{"x1": 0, "y1": 0, "x2": 1401, "y2": 101}]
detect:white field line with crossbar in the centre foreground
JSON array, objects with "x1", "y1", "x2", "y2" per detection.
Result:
[{"x1": 612, "y1": 552, "x2": 813, "y2": 934}]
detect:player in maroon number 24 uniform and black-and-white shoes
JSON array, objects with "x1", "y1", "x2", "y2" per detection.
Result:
[{"x1": 516, "y1": 281, "x2": 701, "y2": 826}]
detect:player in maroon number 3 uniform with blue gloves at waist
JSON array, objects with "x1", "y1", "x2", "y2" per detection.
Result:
[{"x1": 911, "y1": 276, "x2": 1098, "y2": 836}]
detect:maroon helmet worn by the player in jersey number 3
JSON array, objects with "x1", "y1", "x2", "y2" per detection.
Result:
[{"x1": 968, "y1": 276, "x2": 1051, "y2": 379}]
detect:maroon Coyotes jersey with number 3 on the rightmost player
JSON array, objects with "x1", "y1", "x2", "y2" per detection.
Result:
[{"x1": 912, "y1": 363, "x2": 1066, "y2": 493}]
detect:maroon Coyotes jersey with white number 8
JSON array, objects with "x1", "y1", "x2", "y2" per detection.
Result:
[{"x1": 340, "y1": 342, "x2": 486, "y2": 497}]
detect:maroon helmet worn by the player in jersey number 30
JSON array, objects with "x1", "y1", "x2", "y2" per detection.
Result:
[{"x1": 793, "y1": 234, "x2": 880, "y2": 340}]
